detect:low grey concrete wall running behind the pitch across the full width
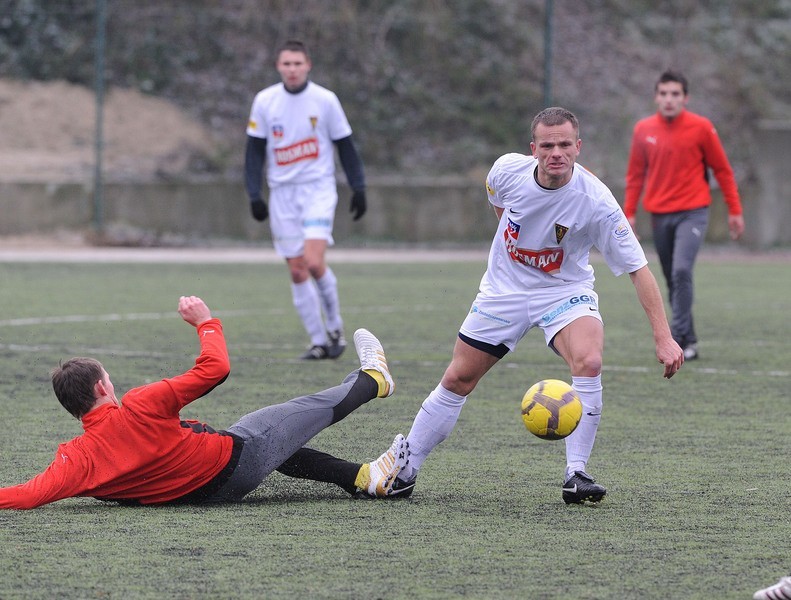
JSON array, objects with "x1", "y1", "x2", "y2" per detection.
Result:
[{"x1": 0, "y1": 171, "x2": 791, "y2": 248}]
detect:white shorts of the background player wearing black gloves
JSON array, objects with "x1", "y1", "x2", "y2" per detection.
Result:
[{"x1": 269, "y1": 178, "x2": 338, "y2": 258}]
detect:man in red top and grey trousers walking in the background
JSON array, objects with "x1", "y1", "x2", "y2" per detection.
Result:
[{"x1": 624, "y1": 71, "x2": 744, "y2": 360}]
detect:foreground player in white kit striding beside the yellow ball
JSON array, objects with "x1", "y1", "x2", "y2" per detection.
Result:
[{"x1": 374, "y1": 107, "x2": 684, "y2": 504}]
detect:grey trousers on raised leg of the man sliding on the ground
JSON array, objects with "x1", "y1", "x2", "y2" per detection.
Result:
[{"x1": 209, "y1": 370, "x2": 377, "y2": 502}]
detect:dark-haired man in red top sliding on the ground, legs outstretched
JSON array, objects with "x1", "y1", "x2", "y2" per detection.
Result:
[{"x1": 0, "y1": 296, "x2": 408, "y2": 509}]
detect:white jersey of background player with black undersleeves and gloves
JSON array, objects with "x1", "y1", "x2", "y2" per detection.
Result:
[{"x1": 247, "y1": 81, "x2": 352, "y2": 188}]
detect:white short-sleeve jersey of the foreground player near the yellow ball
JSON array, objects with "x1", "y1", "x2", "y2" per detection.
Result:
[{"x1": 481, "y1": 153, "x2": 647, "y2": 295}]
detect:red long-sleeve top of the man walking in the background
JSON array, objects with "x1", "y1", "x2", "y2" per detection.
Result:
[{"x1": 623, "y1": 110, "x2": 742, "y2": 217}]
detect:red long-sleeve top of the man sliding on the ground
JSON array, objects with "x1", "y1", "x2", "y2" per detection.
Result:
[{"x1": 0, "y1": 319, "x2": 233, "y2": 509}]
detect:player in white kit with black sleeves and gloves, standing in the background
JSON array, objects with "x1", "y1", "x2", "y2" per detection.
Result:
[{"x1": 245, "y1": 40, "x2": 366, "y2": 359}]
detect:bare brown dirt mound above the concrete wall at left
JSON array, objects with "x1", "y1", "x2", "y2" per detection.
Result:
[{"x1": 0, "y1": 79, "x2": 217, "y2": 182}]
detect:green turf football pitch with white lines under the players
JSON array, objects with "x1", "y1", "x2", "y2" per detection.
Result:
[{"x1": 0, "y1": 255, "x2": 791, "y2": 599}]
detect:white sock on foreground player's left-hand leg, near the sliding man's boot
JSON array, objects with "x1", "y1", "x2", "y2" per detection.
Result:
[{"x1": 398, "y1": 384, "x2": 467, "y2": 481}]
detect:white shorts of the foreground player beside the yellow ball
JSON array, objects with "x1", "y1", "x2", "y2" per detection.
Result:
[{"x1": 459, "y1": 285, "x2": 603, "y2": 352}]
